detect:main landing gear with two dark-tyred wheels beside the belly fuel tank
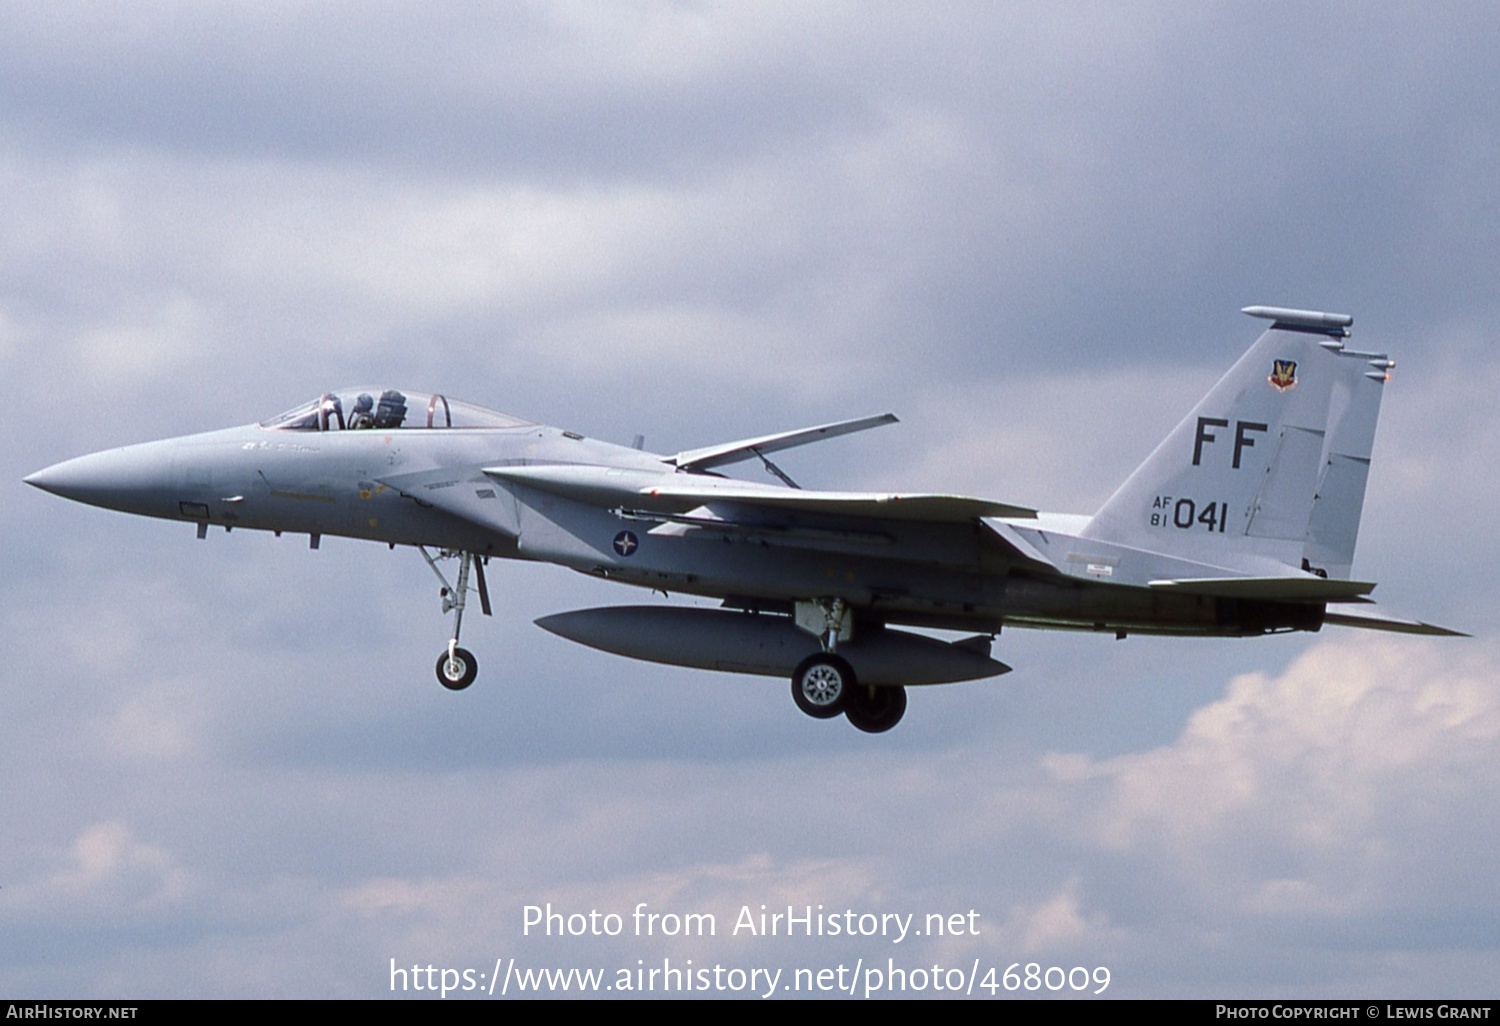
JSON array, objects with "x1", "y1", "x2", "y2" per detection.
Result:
[{"x1": 792, "y1": 599, "x2": 906, "y2": 734}]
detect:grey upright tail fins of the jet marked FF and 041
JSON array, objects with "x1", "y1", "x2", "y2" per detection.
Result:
[{"x1": 1083, "y1": 306, "x2": 1392, "y2": 579}]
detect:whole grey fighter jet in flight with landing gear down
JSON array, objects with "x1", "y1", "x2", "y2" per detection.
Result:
[{"x1": 26, "y1": 306, "x2": 1458, "y2": 734}]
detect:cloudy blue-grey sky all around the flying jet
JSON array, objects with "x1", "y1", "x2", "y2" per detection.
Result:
[{"x1": 0, "y1": 2, "x2": 1500, "y2": 999}]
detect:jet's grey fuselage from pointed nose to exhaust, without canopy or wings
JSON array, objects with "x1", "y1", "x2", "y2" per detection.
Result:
[{"x1": 29, "y1": 411, "x2": 1317, "y2": 635}]
